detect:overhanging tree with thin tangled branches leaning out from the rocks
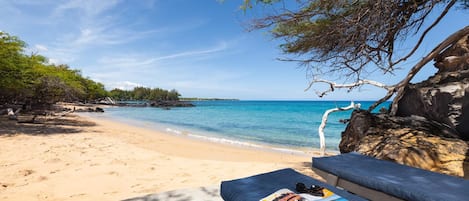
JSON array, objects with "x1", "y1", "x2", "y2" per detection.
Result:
[{"x1": 243, "y1": 0, "x2": 469, "y2": 113}]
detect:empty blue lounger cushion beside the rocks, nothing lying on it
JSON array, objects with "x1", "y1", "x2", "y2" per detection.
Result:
[{"x1": 313, "y1": 153, "x2": 469, "y2": 201}]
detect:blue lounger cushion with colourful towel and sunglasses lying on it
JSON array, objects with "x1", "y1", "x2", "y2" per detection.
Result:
[{"x1": 220, "y1": 168, "x2": 365, "y2": 201}]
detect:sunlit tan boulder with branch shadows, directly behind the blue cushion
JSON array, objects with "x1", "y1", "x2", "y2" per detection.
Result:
[{"x1": 339, "y1": 110, "x2": 469, "y2": 179}]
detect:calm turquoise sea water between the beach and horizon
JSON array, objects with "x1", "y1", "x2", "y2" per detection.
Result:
[{"x1": 97, "y1": 101, "x2": 386, "y2": 150}]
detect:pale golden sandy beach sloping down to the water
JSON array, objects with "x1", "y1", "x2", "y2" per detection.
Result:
[{"x1": 0, "y1": 114, "x2": 317, "y2": 200}]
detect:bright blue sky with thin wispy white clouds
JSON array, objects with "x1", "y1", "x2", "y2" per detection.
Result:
[{"x1": 0, "y1": 0, "x2": 469, "y2": 100}]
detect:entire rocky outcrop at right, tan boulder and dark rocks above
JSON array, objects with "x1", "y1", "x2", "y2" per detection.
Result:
[{"x1": 339, "y1": 32, "x2": 469, "y2": 179}]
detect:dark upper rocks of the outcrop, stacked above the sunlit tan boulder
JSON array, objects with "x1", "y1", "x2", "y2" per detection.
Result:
[{"x1": 396, "y1": 35, "x2": 469, "y2": 140}]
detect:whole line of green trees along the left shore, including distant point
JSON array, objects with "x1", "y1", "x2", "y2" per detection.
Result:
[{"x1": 0, "y1": 32, "x2": 180, "y2": 108}]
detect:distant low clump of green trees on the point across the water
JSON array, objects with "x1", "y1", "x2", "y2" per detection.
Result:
[{"x1": 109, "y1": 87, "x2": 181, "y2": 101}]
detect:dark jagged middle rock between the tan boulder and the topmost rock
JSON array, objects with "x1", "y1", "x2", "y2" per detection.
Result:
[{"x1": 396, "y1": 70, "x2": 469, "y2": 140}]
